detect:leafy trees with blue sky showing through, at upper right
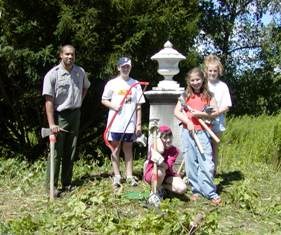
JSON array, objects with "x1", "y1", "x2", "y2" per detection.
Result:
[{"x1": 198, "y1": 0, "x2": 280, "y2": 115}]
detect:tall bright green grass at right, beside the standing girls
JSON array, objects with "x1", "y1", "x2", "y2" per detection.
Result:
[{"x1": 220, "y1": 114, "x2": 281, "y2": 168}]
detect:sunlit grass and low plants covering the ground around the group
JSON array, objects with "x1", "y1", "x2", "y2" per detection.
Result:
[{"x1": 0, "y1": 116, "x2": 281, "y2": 234}]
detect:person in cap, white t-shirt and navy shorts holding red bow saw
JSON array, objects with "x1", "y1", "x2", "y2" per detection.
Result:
[{"x1": 101, "y1": 57, "x2": 145, "y2": 188}]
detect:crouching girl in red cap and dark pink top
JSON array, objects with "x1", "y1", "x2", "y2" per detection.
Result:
[{"x1": 144, "y1": 125, "x2": 186, "y2": 206}]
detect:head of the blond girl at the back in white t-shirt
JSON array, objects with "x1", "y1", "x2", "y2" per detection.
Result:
[{"x1": 204, "y1": 55, "x2": 223, "y2": 82}]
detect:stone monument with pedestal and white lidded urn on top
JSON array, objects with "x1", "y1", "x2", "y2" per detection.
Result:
[{"x1": 144, "y1": 41, "x2": 186, "y2": 162}]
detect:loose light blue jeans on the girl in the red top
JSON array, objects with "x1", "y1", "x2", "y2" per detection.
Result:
[{"x1": 182, "y1": 128, "x2": 219, "y2": 199}]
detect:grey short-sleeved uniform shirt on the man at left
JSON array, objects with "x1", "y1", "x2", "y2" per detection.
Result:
[{"x1": 42, "y1": 64, "x2": 90, "y2": 112}]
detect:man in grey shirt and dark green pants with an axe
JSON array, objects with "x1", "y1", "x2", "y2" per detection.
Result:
[{"x1": 42, "y1": 45, "x2": 90, "y2": 196}]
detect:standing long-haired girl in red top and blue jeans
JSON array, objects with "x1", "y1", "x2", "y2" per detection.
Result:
[{"x1": 174, "y1": 68, "x2": 221, "y2": 205}]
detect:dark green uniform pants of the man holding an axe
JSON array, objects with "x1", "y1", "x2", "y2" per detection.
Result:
[{"x1": 46, "y1": 109, "x2": 81, "y2": 188}]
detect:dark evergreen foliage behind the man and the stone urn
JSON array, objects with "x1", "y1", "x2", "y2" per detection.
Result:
[{"x1": 0, "y1": 0, "x2": 200, "y2": 159}]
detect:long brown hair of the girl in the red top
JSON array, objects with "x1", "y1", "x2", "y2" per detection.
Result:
[{"x1": 185, "y1": 67, "x2": 212, "y2": 101}]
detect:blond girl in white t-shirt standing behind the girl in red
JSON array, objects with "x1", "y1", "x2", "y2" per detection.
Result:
[{"x1": 204, "y1": 55, "x2": 232, "y2": 174}]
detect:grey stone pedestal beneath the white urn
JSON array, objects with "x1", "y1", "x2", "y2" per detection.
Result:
[{"x1": 144, "y1": 88, "x2": 184, "y2": 165}]
